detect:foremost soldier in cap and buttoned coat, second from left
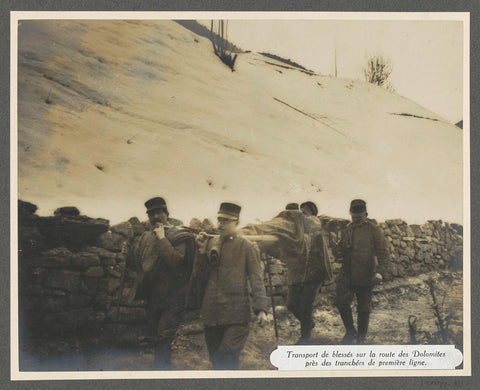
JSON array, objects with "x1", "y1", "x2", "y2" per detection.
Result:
[{"x1": 195, "y1": 203, "x2": 267, "y2": 369}]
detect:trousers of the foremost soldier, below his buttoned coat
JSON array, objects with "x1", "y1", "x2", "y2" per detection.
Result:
[{"x1": 205, "y1": 323, "x2": 249, "y2": 370}]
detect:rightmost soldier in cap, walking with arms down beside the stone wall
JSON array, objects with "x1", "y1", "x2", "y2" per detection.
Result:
[{"x1": 335, "y1": 199, "x2": 389, "y2": 344}]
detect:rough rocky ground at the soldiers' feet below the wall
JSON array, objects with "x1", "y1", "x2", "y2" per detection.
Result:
[{"x1": 20, "y1": 271, "x2": 463, "y2": 371}]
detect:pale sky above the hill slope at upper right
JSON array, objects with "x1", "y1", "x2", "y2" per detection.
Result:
[{"x1": 201, "y1": 20, "x2": 463, "y2": 123}]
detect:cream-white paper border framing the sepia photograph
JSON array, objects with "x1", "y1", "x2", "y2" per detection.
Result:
[{"x1": 10, "y1": 11, "x2": 472, "y2": 381}]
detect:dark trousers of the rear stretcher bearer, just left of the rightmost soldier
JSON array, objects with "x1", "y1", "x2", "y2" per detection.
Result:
[{"x1": 287, "y1": 280, "x2": 321, "y2": 336}]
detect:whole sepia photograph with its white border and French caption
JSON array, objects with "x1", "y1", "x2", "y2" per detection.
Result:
[{"x1": 11, "y1": 12, "x2": 471, "y2": 380}]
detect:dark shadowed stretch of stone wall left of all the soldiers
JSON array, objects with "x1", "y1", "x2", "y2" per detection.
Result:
[{"x1": 18, "y1": 202, "x2": 147, "y2": 352}]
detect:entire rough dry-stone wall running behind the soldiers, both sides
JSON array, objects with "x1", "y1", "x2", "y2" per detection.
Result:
[{"x1": 18, "y1": 201, "x2": 463, "y2": 353}]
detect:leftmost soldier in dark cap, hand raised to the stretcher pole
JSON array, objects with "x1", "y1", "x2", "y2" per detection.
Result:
[{"x1": 127, "y1": 197, "x2": 196, "y2": 369}]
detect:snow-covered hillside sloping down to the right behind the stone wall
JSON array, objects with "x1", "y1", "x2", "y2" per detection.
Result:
[{"x1": 18, "y1": 20, "x2": 463, "y2": 223}]
